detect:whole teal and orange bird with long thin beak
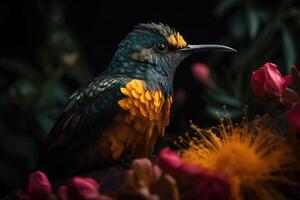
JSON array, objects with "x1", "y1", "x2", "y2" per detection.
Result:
[{"x1": 38, "y1": 22, "x2": 235, "y2": 178}]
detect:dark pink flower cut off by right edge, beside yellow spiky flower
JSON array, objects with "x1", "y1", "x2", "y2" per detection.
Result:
[{"x1": 288, "y1": 102, "x2": 300, "y2": 136}]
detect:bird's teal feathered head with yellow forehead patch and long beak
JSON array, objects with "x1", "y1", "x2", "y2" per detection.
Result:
[{"x1": 109, "y1": 23, "x2": 235, "y2": 94}]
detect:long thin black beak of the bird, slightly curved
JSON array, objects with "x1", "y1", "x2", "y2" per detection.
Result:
[{"x1": 178, "y1": 44, "x2": 237, "y2": 52}]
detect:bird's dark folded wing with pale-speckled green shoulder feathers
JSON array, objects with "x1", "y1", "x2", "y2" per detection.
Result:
[{"x1": 39, "y1": 76, "x2": 130, "y2": 168}]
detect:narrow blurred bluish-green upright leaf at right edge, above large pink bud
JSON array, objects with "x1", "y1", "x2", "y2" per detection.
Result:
[{"x1": 282, "y1": 26, "x2": 297, "y2": 72}]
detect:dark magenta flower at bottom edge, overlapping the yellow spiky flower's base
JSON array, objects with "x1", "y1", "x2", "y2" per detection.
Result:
[{"x1": 193, "y1": 173, "x2": 230, "y2": 200}]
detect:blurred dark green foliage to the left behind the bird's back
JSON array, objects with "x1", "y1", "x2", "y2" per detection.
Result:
[{"x1": 0, "y1": 1, "x2": 91, "y2": 193}]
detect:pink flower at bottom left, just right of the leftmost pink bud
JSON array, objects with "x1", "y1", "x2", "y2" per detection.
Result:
[{"x1": 58, "y1": 177, "x2": 100, "y2": 200}]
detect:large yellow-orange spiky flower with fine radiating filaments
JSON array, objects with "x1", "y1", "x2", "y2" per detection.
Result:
[{"x1": 180, "y1": 111, "x2": 299, "y2": 200}]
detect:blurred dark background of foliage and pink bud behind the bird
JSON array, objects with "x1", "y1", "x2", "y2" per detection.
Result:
[{"x1": 0, "y1": 0, "x2": 300, "y2": 197}]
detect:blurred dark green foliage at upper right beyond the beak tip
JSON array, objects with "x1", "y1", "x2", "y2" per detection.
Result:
[{"x1": 204, "y1": 0, "x2": 300, "y2": 119}]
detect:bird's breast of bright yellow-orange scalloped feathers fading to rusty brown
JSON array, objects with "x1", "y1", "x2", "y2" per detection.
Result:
[{"x1": 103, "y1": 79, "x2": 172, "y2": 159}]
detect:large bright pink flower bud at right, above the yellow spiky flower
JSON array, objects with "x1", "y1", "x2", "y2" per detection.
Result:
[{"x1": 251, "y1": 63, "x2": 292, "y2": 101}]
